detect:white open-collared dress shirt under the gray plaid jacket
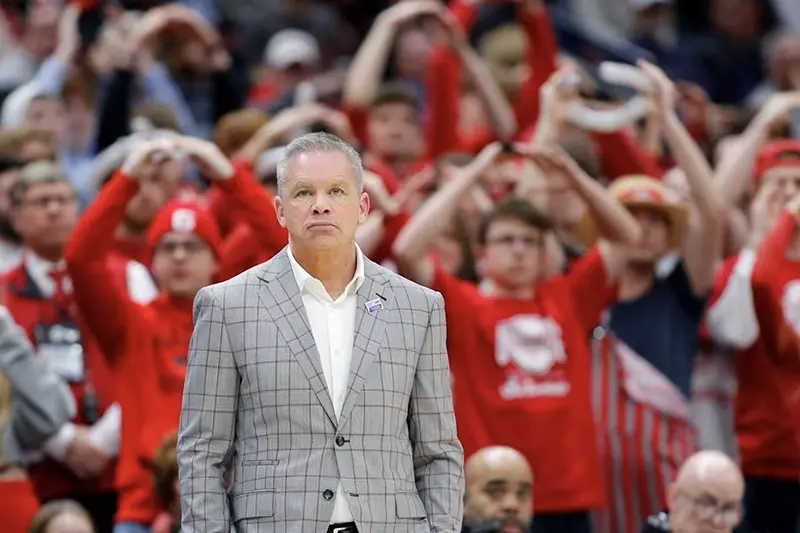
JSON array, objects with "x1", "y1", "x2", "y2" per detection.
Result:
[{"x1": 287, "y1": 245, "x2": 364, "y2": 524}]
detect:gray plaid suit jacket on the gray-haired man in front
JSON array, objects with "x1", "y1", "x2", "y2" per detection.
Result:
[{"x1": 178, "y1": 249, "x2": 464, "y2": 533}]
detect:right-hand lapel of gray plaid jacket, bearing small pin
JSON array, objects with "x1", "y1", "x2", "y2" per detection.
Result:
[{"x1": 339, "y1": 257, "x2": 393, "y2": 424}]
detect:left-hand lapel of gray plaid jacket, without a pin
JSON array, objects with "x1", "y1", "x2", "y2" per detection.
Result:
[{"x1": 253, "y1": 248, "x2": 337, "y2": 426}]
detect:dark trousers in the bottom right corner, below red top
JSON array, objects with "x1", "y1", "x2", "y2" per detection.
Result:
[{"x1": 744, "y1": 477, "x2": 800, "y2": 533}]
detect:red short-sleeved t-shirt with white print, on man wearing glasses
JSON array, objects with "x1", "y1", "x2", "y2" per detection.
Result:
[{"x1": 432, "y1": 250, "x2": 615, "y2": 512}]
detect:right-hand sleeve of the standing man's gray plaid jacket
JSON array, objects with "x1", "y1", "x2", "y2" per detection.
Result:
[{"x1": 408, "y1": 293, "x2": 464, "y2": 533}]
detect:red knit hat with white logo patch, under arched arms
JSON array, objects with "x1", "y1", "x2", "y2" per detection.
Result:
[{"x1": 147, "y1": 200, "x2": 222, "y2": 258}]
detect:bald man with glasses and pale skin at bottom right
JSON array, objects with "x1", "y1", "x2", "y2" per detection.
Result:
[{"x1": 642, "y1": 450, "x2": 744, "y2": 533}]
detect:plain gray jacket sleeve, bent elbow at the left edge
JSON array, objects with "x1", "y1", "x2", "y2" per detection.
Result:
[{"x1": 0, "y1": 306, "x2": 76, "y2": 464}]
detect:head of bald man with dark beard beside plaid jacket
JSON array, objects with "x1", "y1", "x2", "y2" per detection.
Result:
[{"x1": 463, "y1": 446, "x2": 533, "y2": 533}]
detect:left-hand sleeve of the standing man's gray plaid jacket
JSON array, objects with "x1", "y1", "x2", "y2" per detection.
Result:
[{"x1": 178, "y1": 287, "x2": 240, "y2": 533}]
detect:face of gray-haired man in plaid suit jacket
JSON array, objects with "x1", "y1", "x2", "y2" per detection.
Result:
[{"x1": 275, "y1": 151, "x2": 369, "y2": 248}]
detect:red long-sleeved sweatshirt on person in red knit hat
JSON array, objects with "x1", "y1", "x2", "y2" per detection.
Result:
[{"x1": 66, "y1": 167, "x2": 284, "y2": 523}]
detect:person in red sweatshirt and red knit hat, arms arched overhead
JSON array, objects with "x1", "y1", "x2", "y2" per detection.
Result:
[{"x1": 65, "y1": 137, "x2": 275, "y2": 533}]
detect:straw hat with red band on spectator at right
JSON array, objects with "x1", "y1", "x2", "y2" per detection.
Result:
[{"x1": 609, "y1": 176, "x2": 689, "y2": 250}]
